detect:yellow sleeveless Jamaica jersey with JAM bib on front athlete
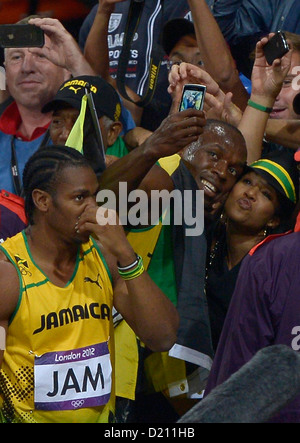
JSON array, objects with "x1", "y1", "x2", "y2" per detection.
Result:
[{"x1": 0, "y1": 231, "x2": 115, "y2": 423}]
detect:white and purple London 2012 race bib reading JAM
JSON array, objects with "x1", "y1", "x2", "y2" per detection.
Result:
[{"x1": 34, "y1": 343, "x2": 112, "y2": 411}]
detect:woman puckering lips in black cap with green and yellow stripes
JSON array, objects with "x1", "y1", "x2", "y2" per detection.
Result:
[{"x1": 206, "y1": 152, "x2": 299, "y2": 350}]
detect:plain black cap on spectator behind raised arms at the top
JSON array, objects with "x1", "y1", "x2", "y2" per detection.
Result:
[{"x1": 162, "y1": 18, "x2": 195, "y2": 55}]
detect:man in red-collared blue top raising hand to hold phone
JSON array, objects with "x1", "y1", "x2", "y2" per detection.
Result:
[{"x1": 0, "y1": 19, "x2": 94, "y2": 195}]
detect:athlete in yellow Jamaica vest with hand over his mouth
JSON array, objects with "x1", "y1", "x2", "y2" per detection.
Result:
[{"x1": 0, "y1": 147, "x2": 178, "y2": 423}]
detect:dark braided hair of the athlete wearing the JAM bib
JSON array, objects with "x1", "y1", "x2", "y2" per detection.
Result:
[{"x1": 23, "y1": 145, "x2": 92, "y2": 224}]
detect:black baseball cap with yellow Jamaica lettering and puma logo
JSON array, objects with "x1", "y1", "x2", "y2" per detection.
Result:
[{"x1": 42, "y1": 75, "x2": 121, "y2": 121}]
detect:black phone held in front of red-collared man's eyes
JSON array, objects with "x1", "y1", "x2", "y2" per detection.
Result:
[{"x1": 0, "y1": 25, "x2": 45, "y2": 48}]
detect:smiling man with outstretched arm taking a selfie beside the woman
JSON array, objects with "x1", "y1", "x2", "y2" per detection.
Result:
[{"x1": 100, "y1": 110, "x2": 246, "y2": 423}]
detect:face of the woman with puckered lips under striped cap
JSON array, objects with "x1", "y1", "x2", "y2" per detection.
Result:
[{"x1": 225, "y1": 172, "x2": 279, "y2": 234}]
